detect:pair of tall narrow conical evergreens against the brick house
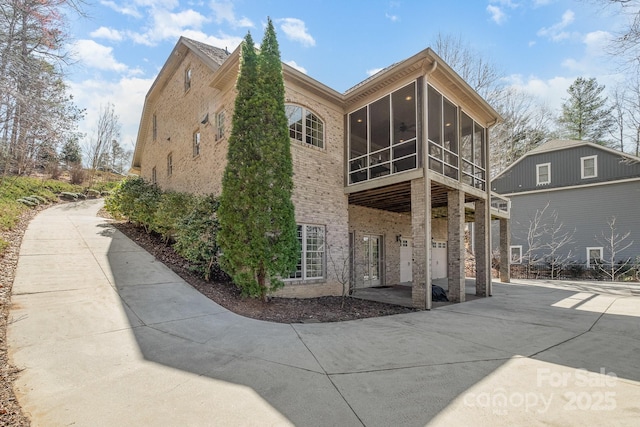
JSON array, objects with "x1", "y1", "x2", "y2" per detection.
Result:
[{"x1": 218, "y1": 19, "x2": 299, "y2": 300}]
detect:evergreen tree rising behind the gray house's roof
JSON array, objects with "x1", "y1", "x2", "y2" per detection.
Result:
[{"x1": 559, "y1": 77, "x2": 613, "y2": 145}]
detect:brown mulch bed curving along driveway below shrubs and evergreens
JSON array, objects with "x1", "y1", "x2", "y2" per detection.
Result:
[{"x1": 109, "y1": 219, "x2": 415, "y2": 323}]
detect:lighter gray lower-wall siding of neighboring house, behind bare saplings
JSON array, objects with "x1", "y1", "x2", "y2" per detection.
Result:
[{"x1": 511, "y1": 182, "x2": 640, "y2": 263}]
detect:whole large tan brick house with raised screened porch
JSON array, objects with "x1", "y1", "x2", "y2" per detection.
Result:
[{"x1": 132, "y1": 37, "x2": 508, "y2": 309}]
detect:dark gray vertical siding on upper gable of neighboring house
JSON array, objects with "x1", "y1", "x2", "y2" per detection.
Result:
[{"x1": 491, "y1": 146, "x2": 640, "y2": 194}]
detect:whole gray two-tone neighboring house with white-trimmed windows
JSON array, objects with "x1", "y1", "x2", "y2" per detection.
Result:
[{"x1": 491, "y1": 140, "x2": 640, "y2": 274}]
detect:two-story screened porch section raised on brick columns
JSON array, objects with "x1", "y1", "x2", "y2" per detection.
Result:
[{"x1": 345, "y1": 49, "x2": 508, "y2": 308}]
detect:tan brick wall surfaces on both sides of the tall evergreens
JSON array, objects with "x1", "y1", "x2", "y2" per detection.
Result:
[{"x1": 141, "y1": 52, "x2": 349, "y2": 297}]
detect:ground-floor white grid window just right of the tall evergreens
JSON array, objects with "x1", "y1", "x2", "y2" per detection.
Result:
[{"x1": 289, "y1": 224, "x2": 325, "y2": 280}]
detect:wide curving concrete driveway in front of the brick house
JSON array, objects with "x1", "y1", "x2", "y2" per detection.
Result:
[{"x1": 8, "y1": 201, "x2": 640, "y2": 426}]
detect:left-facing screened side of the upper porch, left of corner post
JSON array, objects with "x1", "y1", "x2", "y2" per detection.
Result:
[{"x1": 348, "y1": 82, "x2": 418, "y2": 184}]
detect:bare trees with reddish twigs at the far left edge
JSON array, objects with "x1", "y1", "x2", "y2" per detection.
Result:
[{"x1": 0, "y1": 0, "x2": 82, "y2": 174}]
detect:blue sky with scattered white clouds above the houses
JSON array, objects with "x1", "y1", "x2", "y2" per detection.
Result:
[{"x1": 67, "y1": 0, "x2": 628, "y2": 148}]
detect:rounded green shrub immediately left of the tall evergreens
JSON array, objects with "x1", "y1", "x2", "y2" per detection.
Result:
[{"x1": 173, "y1": 195, "x2": 228, "y2": 281}]
